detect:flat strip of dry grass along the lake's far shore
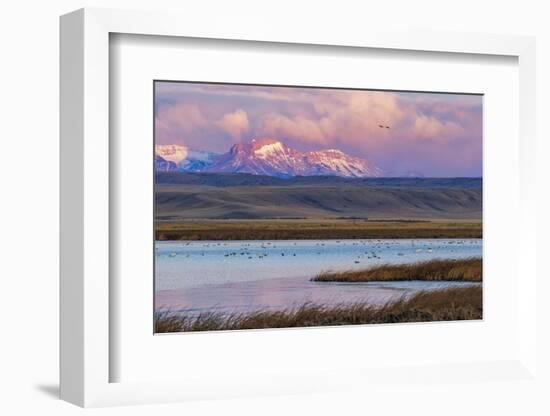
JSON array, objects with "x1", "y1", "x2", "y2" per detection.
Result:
[{"x1": 155, "y1": 218, "x2": 482, "y2": 240}]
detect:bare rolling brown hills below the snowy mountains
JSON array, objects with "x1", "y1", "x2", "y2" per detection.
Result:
[{"x1": 155, "y1": 183, "x2": 482, "y2": 220}]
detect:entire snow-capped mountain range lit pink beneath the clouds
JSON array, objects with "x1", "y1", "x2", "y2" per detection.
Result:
[{"x1": 157, "y1": 139, "x2": 383, "y2": 178}]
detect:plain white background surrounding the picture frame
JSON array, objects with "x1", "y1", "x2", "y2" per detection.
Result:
[{"x1": 0, "y1": 0, "x2": 550, "y2": 415}]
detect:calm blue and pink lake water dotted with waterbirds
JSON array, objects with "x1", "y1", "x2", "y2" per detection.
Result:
[{"x1": 155, "y1": 239, "x2": 482, "y2": 314}]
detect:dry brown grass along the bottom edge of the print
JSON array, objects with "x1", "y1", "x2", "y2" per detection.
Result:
[{"x1": 155, "y1": 285, "x2": 482, "y2": 333}]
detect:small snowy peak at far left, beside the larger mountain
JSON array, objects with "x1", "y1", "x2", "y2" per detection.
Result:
[{"x1": 155, "y1": 144, "x2": 219, "y2": 172}]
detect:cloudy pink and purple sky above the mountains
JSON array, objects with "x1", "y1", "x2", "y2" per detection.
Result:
[{"x1": 155, "y1": 81, "x2": 482, "y2": 177}]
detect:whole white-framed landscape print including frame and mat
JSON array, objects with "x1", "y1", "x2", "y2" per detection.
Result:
[{"x1": 60, "y1": 9, "x2": 538, "y2": 406}]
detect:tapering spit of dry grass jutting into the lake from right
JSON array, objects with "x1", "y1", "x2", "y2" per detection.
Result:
[{"x1": 311, "y1": 258, "x2": 482, "y2": 282}]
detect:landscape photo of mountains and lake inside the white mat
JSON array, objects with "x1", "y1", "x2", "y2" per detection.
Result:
[{"x1": 154, "y1": 80, "x2": 483, "y2": 333}]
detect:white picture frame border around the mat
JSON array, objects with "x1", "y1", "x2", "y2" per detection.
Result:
[{"x1": 60, "y1": 9, "x2": 537, "y2": 407}]
